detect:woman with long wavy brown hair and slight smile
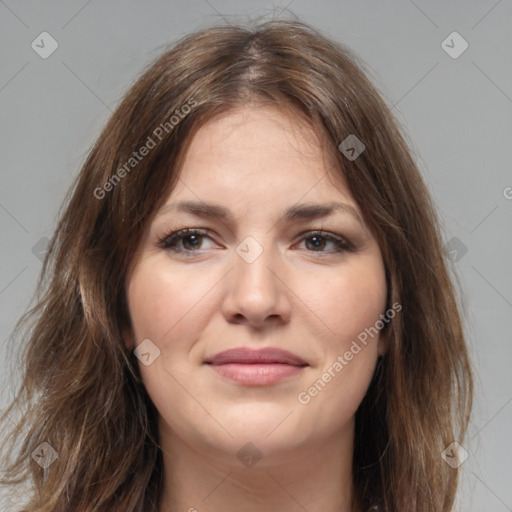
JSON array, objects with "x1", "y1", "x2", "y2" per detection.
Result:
[{"x1": 0, "y1": 21, "x2": 472, "y2": 512}]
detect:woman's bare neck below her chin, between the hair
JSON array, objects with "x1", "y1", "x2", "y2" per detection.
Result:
[{"x1": 158, "y1": 421, "x2": 354, "y2": 512}]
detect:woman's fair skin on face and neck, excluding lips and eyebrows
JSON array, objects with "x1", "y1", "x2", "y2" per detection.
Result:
[{"x1": 127, "y1": 105, "x2": 386, "y2": 512}]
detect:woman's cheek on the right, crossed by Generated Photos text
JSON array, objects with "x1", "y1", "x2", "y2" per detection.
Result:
[{"x1": 290, "y1": 257, "x2": 387, "y2": 420}]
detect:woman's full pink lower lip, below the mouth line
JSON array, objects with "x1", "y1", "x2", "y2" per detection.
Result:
[{"x1": 210, "y1": 363, "x2": 305, "y2": 386}]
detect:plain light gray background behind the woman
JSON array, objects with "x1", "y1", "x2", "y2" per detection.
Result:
[{"x1": 0, "y1": 0, "x2": 512, "y2": 512}]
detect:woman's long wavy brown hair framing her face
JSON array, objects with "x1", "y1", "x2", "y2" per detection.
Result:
[{"x1": 2, "y1": 20, "x2": 473, "y2": 512}]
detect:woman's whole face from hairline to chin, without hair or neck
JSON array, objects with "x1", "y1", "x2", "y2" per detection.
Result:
[{"x1": 127, "y1": 106, "x2": 386, "y2": 464}]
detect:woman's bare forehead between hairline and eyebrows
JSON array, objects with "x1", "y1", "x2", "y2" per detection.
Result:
[{"x1": 171, "y1": 105, "x2": 350, "y2": 205}]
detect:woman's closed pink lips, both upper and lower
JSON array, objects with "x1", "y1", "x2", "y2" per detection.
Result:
[{"x1": 205, "y1": 348, "x2": 308, "y2": 386}]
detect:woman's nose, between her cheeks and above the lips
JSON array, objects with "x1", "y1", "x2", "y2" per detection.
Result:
[{"x1": 222, "y1": 240, "x2": 292, "y2": 329}]
